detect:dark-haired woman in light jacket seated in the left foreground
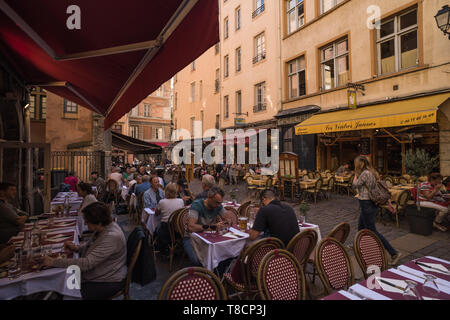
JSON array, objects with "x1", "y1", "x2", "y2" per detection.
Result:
[{"x1": 43, "y1": 202, "x2": 127, "y2": 300}]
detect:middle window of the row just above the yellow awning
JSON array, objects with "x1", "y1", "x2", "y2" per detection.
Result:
[{"x1": 320, "y1": 38, "x2": 349, "y2": 90}]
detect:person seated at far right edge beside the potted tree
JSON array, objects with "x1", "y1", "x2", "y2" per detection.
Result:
[{"x1": 419, "y1": 173, "x2": 449, "y2": 232}]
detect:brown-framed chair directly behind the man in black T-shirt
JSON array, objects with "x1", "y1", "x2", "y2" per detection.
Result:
[{"x1": 224, "y1": 237, "x2": 284, "y2": 300}]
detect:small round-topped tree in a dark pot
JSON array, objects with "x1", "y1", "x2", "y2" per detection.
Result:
[{"x1": 405, "y1": 149, "x2": 439, "y2": 236}]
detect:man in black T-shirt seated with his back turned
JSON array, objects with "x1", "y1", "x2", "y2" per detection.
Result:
[{"x1": 250, "y1": 190, "x2": 300, "y2": 245}]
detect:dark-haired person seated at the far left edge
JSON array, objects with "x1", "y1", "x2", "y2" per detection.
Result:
[{"x1": 0, "y1": 182, "x2": 28, "y2": 244}]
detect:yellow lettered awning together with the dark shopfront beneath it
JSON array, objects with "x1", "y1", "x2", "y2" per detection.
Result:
[{"x1": 295, "y1": 92, "x2": 450, "y2": 174}]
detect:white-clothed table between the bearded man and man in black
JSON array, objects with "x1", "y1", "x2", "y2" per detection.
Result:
[{"x1": 191, "y1": 227, "x2": 249, "y2": 271}]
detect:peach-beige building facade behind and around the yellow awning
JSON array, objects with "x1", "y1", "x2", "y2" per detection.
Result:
[{"x1": 278, "y1": 0, "x2": 450, "y2": 175}]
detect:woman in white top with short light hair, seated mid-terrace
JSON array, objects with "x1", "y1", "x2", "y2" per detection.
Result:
[{"x1": 155, "y1": 183, "x2": 184, "y2": 253}]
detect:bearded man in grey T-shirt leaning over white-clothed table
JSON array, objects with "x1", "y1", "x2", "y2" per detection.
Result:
[{"x1": 183, "y1": 187, "x2": 226, "y2": 266}]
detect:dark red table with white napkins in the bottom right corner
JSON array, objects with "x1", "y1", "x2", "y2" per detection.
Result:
[{"x1": 323, "y1": 256, "x2": 450, "y2": 300}]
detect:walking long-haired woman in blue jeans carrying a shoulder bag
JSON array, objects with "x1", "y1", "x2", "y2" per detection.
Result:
[{"x1": 353, "y1": 156, "x2": 400, "y2": 264}]
